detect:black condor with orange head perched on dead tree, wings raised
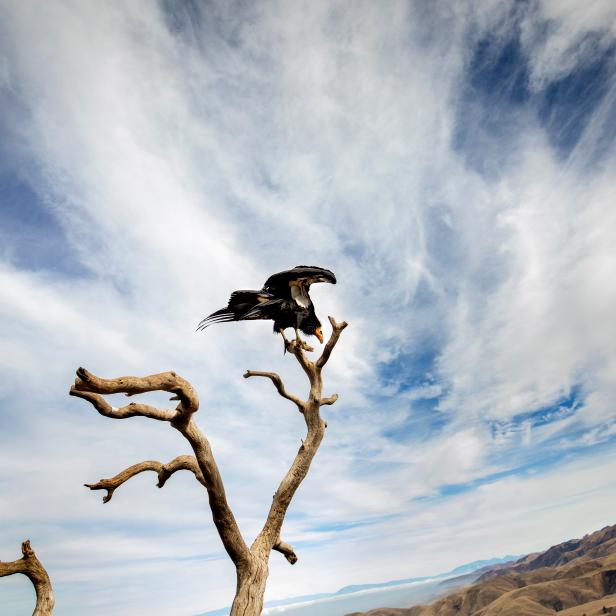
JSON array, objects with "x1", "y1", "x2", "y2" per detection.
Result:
[{"x1": 197, "y1": 265, "x2": 336, "y2": 343}]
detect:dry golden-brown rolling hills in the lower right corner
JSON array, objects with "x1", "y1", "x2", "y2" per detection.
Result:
[{"x1": 347, "y1": 525, "x2": 616, "y2": 616}]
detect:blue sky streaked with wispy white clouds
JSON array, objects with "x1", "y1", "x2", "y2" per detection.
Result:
[{"x1": 0, "y1": 0, "x2": 616, "y2": 616}]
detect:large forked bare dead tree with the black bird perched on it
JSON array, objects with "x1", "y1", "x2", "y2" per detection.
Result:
[{"x1": 70, "y1": 317, "x2": 347, "y2": 616}]
